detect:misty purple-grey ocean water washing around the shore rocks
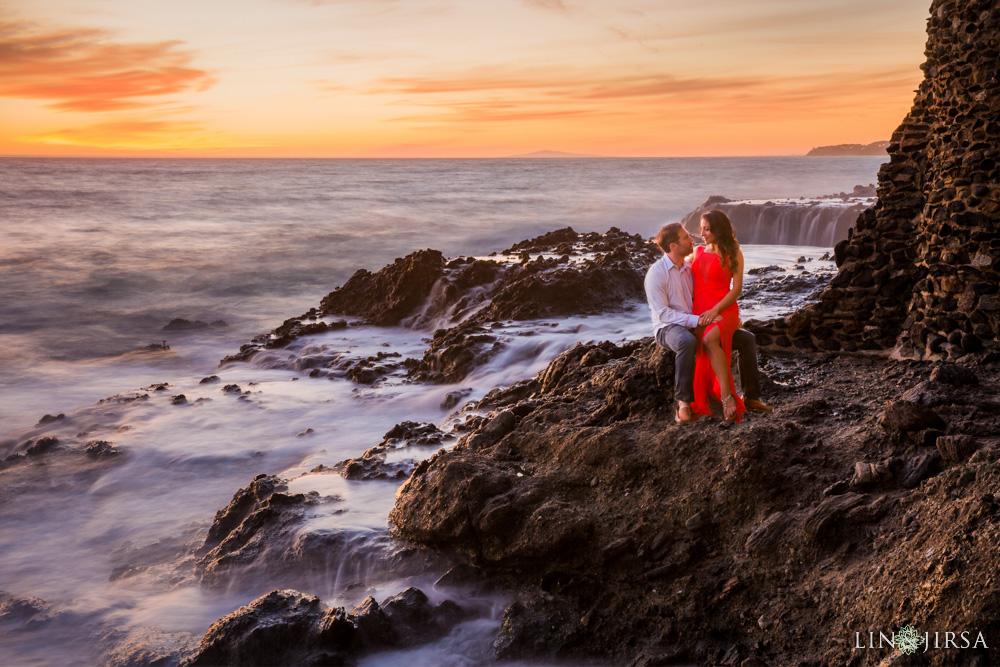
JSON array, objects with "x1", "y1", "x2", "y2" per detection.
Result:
[{"x1": 0, "y1": 157, "x2": 882, "y2": 666}]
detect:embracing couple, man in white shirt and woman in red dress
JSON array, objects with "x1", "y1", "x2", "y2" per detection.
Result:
[{"x1": 645, "y1": 211, "x2": 771, "y2": 424}]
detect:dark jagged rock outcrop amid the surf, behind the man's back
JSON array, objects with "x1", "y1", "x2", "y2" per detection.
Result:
[{"x1": 222, "y1": 227, "x2": 661, "y2": 385}]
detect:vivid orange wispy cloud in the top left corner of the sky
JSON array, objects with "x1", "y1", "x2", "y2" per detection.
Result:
[{"x1": 0, "y1": 22, "x2": 214, "y2": 112}]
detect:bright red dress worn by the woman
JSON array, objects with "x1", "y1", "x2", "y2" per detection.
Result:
[{"x1": 691, "y1": 246, "x2": 746, "y2": 422}]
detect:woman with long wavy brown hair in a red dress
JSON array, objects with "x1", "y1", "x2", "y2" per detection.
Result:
[{"x1": 691, "y1": 211, "x2": 746, "y2": 422}]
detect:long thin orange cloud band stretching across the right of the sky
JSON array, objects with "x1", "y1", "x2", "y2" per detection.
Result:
[{"x1": 369, "y1": 63, "x2": 919, "y2": 129}]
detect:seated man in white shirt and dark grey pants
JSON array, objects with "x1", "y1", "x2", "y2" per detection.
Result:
[{"x1": 645, "y1": 222, "x2": 771, "y2": 424}]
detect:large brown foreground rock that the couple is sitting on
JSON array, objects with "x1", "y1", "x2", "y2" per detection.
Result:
[{"x1": 390, "y1": 339, "x2": 1000, "y2": 665}]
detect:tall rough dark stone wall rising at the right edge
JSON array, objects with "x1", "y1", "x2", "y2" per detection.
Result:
[{"x1": 754, "y1": 0, "x2": 1000, "y2": 360}]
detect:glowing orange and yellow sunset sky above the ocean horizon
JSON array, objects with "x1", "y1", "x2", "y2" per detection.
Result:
[{"x1": 0, "y1": 0, "x2": 930, "y2": 157}]
